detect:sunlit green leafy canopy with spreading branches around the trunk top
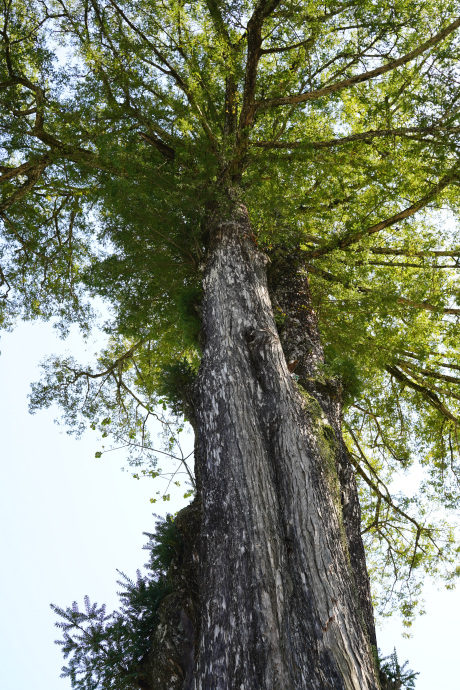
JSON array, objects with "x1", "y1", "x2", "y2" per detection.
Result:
[{"x1": 0, "y1": 0, "x2": 460, "y2": 623}]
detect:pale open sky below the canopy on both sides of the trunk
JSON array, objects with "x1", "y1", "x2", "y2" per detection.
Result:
[{"x1": 0, "y1": 323, "x2": 460, "y2": 690}]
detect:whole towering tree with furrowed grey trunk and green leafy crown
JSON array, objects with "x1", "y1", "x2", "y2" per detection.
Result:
[{"x1": 0, "y1": 0, "x2": 460, "y2": 690}]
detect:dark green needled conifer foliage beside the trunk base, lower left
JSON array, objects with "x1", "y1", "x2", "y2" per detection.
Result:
[{"x1": 51, "y1": 515, "x2": 181, "y2": 690}]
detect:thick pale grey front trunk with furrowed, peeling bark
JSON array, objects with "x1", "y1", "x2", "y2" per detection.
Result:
[{"x1": 195, "y1": 204, "x2": 379, "y2": 690}]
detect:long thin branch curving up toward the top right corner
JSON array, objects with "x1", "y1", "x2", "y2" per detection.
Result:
[{"x1": 256, "y1": 18, "x2": 460, "y2": 108}]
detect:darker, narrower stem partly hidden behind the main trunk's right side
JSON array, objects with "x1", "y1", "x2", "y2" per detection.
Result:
[{"x1": 268, "y1": 248, "x2": 377, "y2": 649}]
